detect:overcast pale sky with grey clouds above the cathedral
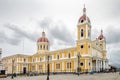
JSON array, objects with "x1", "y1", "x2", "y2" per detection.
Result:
[{"x1": 0, "y1": 0, "x2": 120, "y2": 67}]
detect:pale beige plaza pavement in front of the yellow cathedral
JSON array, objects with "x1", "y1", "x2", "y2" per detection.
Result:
[{"x1": 0, "y1": 73, "x2": 120, "y2": 80}]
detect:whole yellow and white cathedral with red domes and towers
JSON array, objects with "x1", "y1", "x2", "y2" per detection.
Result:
[{"x1": 2, "y1": 7, "x2": 108, "y2": 74}]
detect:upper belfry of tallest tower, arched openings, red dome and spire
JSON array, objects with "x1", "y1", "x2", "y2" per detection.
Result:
[{"x1": 77, "y1": 6, "x2": 91, "y2": 41}]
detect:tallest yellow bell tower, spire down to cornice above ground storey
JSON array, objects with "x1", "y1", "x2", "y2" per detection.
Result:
[{"x1": 76, "y1": 5, "x2": 91, "y2": 54}]
